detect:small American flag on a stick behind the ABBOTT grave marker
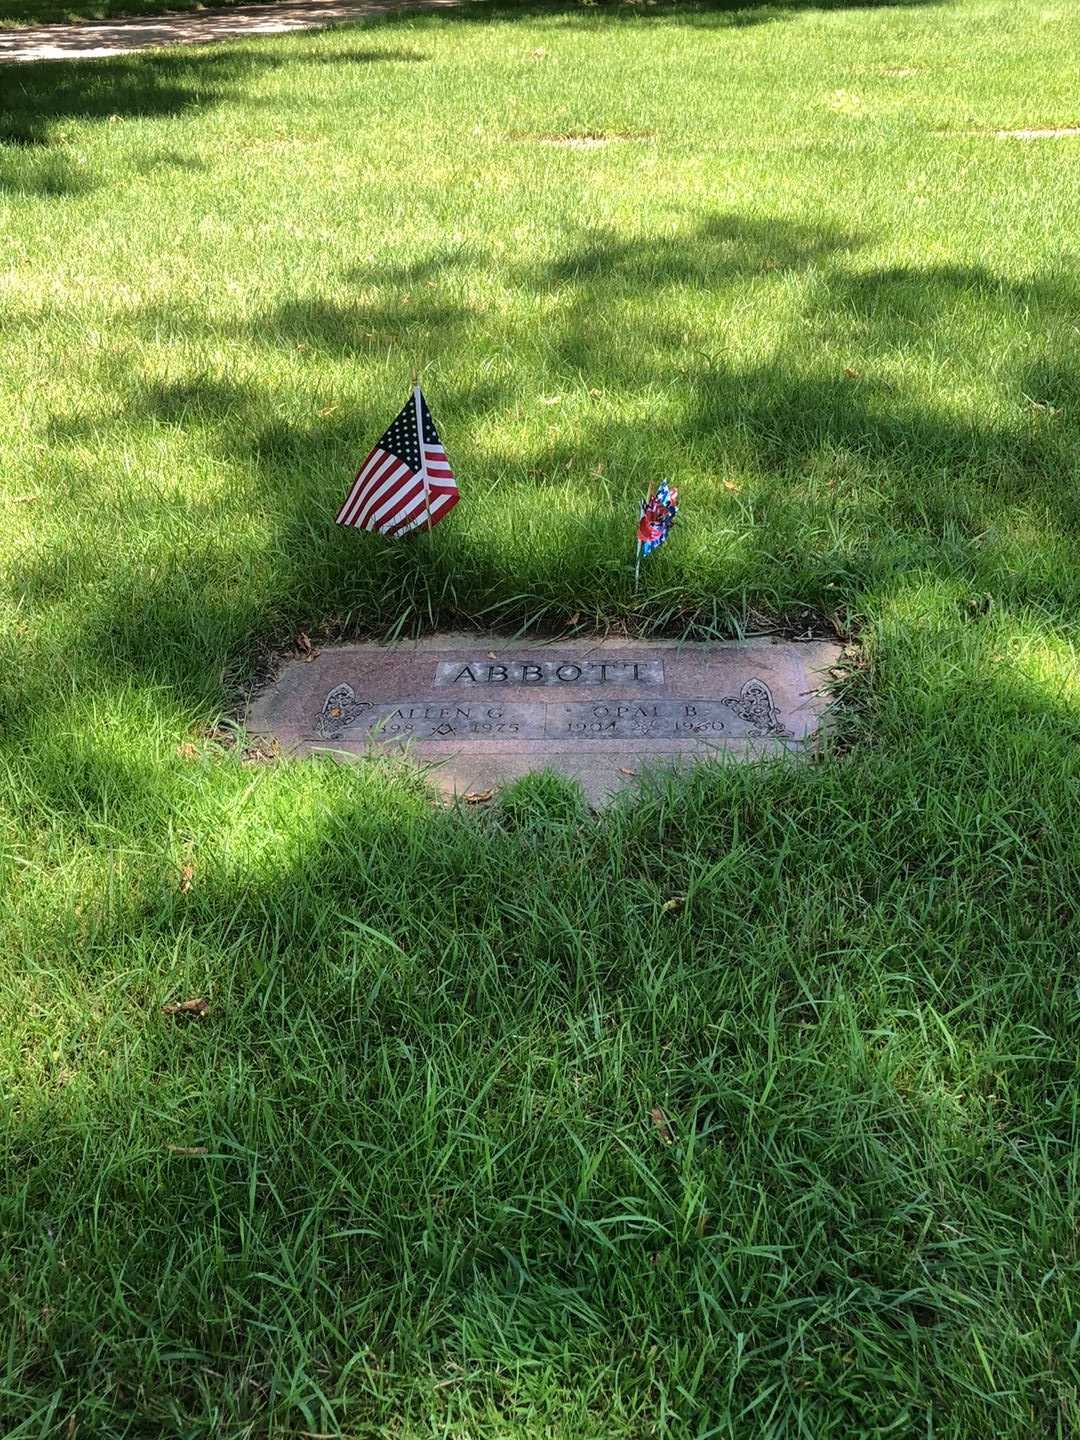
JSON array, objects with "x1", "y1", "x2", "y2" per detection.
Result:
[{"x1": 337, "y1": 384, "x2": 461, "y2": 536}]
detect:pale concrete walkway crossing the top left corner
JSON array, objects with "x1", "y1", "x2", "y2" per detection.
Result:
[{"x1": 0, "y1": 0, "x2": 458, "y2": 63}]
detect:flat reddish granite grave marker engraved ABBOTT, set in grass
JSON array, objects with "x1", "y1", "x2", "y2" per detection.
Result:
[{"x1": 249, "y1": 635, "x2": 842, "y2": 804}]
